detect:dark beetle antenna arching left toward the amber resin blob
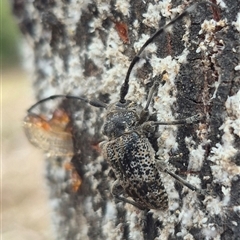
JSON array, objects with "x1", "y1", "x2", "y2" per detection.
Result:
[{"x1": 27, "y1": 95, "x2": 107, "y2": 113}]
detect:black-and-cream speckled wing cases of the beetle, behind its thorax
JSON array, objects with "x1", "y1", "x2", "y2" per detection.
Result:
[{"x1": 102, "y1": 127, "x2": 168, "y2": 210}]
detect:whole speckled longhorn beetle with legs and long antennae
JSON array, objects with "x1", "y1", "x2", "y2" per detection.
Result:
[{"x1": 24, "y1": 1, "x2": 215, "y2": 210}]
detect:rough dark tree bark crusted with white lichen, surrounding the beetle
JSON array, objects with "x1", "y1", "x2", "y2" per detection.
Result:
[{"x1": 13, "y1": 0, "x2": 240, "y2": 240}]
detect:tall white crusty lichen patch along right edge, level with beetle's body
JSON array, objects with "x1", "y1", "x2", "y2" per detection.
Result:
[{"x1": 204, "y1": 91, "x2": 240, "y2": 223}]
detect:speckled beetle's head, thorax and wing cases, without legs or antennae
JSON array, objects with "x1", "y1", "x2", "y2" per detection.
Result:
[{"x1": 101, "y1": 103, "x2": 168, "y2": 210}]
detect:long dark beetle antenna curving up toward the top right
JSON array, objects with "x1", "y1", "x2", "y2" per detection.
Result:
[{"x1": 119, "y1": 1, "x2": 217, "y2": 103}]
